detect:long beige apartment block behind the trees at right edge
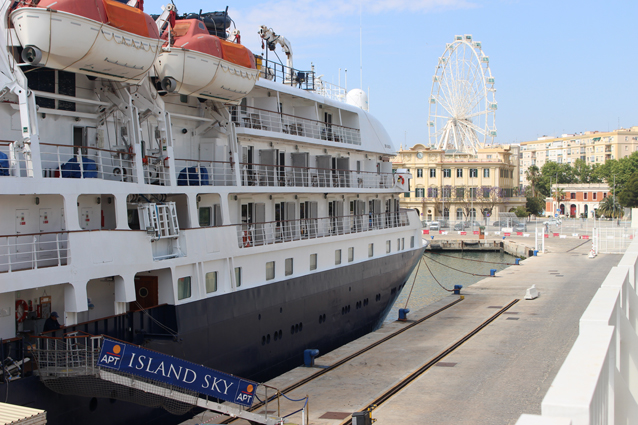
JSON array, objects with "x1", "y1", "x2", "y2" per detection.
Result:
[{"x1": 520, "y1": 127, "x2": 638, "y2": 184}]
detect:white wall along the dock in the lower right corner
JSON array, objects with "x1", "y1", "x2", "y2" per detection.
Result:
[{"x1": 517, "y1": 241, "x2": 638, "y2": 425}]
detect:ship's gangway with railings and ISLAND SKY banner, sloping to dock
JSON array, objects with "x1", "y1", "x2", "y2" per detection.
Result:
[{"x1": 32, "y1": 332, "x2": 308, "y2": 425}]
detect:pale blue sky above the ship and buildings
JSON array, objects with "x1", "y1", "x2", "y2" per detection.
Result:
[{"x1": 144, "y1": 0, "x2": 638, "y2": 148}]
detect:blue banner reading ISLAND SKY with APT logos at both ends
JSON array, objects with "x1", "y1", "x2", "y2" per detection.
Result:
[{"x1": 97, "y1": 338, "x2": 257, "y2": 407}]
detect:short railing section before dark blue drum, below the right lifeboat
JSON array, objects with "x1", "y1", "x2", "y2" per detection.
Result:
[{"x1": 175, "y1": 159, "x2": 235, "y2": 186}]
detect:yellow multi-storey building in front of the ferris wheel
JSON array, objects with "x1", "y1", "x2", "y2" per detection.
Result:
[{"x1": 392, "y1": 144, "x2": 525, "y2": 222}]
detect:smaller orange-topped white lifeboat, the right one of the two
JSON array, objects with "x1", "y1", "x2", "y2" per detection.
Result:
[{"x1": 156, "y1": 19, "x2": 259, "y2": 103}]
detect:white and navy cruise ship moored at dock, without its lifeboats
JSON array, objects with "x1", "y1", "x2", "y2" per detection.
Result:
[{"x1": 0, "y1": 0, "x2": 423, "y2": 423}]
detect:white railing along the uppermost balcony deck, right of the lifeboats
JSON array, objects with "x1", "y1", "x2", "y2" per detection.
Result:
[{"x1": 231, "y1": 106, "x2": 361, "y2": 145}]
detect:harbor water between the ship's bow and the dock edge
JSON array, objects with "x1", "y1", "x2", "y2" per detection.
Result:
[{"x1": 384, "y1": 251, "x2": 514, "y2": 323}]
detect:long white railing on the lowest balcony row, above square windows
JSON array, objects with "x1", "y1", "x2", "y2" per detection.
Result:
[{"x1": 235, "y1": 210, "x2": 410, "y2": 248}]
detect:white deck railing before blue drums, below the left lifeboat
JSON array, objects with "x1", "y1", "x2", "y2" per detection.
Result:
[{"x1": 40, "y1": 143, "x2": 137, "y2": 183}]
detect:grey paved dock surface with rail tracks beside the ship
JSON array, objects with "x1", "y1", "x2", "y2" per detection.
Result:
[{"x1": 185, "y1": 238, "x2": 621, "y2": 425}]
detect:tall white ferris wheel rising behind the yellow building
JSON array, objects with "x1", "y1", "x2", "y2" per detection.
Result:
[{"x1": 428, "y1": 34, "x2": 497, "y2": 154}]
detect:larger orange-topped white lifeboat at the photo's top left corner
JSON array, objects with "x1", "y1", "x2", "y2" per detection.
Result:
[{"x1": 10, "y1": 0, "x2": 164, "y2": 81}]
